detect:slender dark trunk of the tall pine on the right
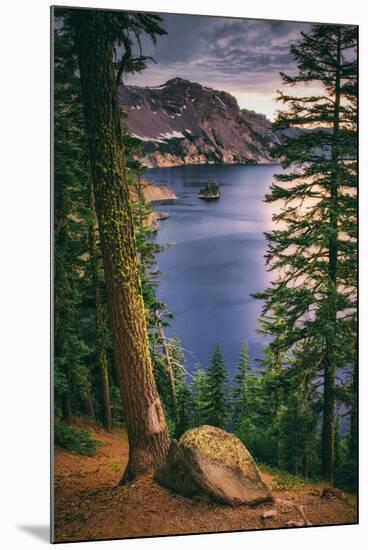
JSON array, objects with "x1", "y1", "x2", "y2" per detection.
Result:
[{"x1": 322, "y1": 31, "x2": 341, "y2": 484}]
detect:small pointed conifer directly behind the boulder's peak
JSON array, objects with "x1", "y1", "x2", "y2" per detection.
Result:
[{"x1": 205, "y1": 345, "x2": 231, "y2": 429}]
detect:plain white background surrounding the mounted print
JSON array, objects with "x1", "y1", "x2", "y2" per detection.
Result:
[{"x1": 0, "y1": 0, "x2": 368, "y2": 550}]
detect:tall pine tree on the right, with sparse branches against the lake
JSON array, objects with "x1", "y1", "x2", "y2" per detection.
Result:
[{"x1": 259, "y1": 25, "x2": 357, "y2": 482}]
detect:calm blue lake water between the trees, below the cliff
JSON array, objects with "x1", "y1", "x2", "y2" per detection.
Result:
[{"x1": 145, "y1": 164, "x2": 282, "y2": 373}]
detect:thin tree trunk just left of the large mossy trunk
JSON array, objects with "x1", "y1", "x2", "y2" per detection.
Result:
[{"x1": 88, "y1": 185, "x2": 112, "y2": 432}]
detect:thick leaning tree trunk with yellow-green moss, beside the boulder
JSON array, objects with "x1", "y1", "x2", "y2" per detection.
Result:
[{"x1": 72, "y1": 10, "x2": 169, "y2": 482}]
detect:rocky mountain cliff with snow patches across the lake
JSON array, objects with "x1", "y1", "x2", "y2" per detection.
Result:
[{"x1": 119, "y1": 78, "x2": 275, "y2": 166}]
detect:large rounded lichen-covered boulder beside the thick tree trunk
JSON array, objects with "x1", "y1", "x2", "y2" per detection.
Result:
[{"x1": 156, "y1": 426, "x2": 273, "y2": 506}]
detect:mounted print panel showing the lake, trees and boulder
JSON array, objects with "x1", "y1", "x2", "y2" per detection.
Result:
[{"x1": 52, "y1": 7, "x2": 358, "y2": 542}]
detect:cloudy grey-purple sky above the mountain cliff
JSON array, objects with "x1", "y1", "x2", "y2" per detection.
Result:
[{"x1": 126, "y1": 14, "x2": 310, "y2": 120}]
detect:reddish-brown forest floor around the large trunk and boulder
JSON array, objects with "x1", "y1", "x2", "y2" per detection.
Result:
[{"x1": 55, "y1": 428, "x2": 357, "y2": 542}]
